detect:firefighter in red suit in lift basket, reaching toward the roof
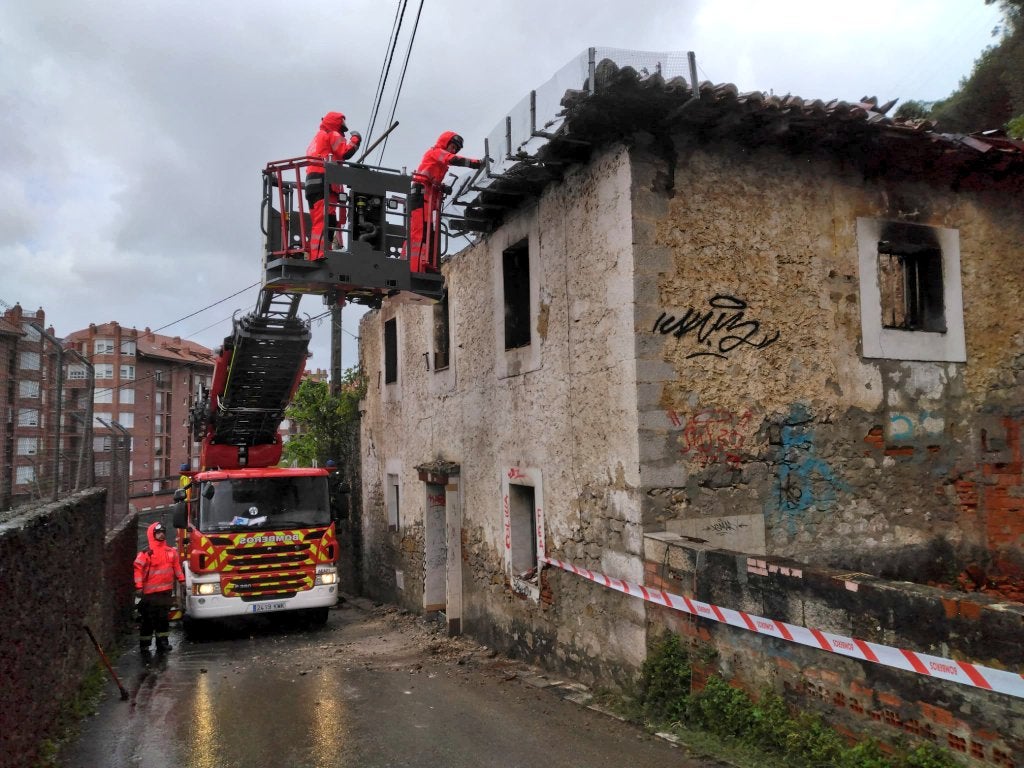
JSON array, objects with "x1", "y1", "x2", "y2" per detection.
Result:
[{"x1": 409, "y1": 131, "x2": 483, "y2": 272}]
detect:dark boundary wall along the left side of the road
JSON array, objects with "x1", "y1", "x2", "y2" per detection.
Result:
[{"x1": 0, "y1": 488, "x2": 135, "y2": 768}]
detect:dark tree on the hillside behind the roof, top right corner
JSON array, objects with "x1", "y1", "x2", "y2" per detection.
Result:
[{"x1": 929, "y1": 0, "x2": 1024, "y2": 133}]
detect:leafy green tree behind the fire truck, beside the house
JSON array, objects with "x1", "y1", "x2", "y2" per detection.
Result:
[{"x1": 284, "y1": 368, "x2": 366, "y2": 467}]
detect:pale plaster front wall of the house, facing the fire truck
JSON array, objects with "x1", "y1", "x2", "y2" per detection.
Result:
[{"x1": 360, "y1": 148, "x2": 644, "y2": 677}]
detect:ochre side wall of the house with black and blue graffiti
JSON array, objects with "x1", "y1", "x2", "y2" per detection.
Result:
[{"x1": 633, "y1": 138, "x2": 1024, "y2": 580}]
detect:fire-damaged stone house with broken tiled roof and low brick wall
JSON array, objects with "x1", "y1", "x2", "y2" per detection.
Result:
[{"x1": 360, "y1": 50, "x2": 1024, "y2": 765}]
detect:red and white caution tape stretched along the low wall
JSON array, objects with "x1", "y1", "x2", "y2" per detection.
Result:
[{"x1": 543, "y1": 557, "x2": 1024, "y2": 698}]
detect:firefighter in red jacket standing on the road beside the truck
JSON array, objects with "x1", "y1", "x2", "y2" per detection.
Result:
[{"x1": 135, "y1": 520, "x2": 185, "y2": 654}]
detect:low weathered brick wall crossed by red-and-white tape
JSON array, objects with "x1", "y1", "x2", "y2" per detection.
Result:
[{"x1": 644, "y1": 535, "x2": 1024, "y2": 766}]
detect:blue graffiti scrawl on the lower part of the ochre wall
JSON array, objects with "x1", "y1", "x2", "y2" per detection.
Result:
[{"x1": 775, "y1": 404, "x2": 848, "y2": 534}]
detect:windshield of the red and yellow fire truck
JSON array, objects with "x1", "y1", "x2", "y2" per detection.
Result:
[{"x1": 199, "y1": 477, "x2": 331, "y2": 531}]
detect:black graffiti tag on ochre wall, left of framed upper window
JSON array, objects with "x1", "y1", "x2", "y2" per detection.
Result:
[{"x1": 651, "y1": 294, "x2": 779, "y2": 359}]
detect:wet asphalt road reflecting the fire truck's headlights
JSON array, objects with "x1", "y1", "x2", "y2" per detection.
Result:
[{"x1": 60, "y1": 600, "x2": 716, "y2": 768}]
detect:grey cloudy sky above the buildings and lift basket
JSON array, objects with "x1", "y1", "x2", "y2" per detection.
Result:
[{"x1": 0, "y1": 0, "x2": 999, "y2": 368}]
